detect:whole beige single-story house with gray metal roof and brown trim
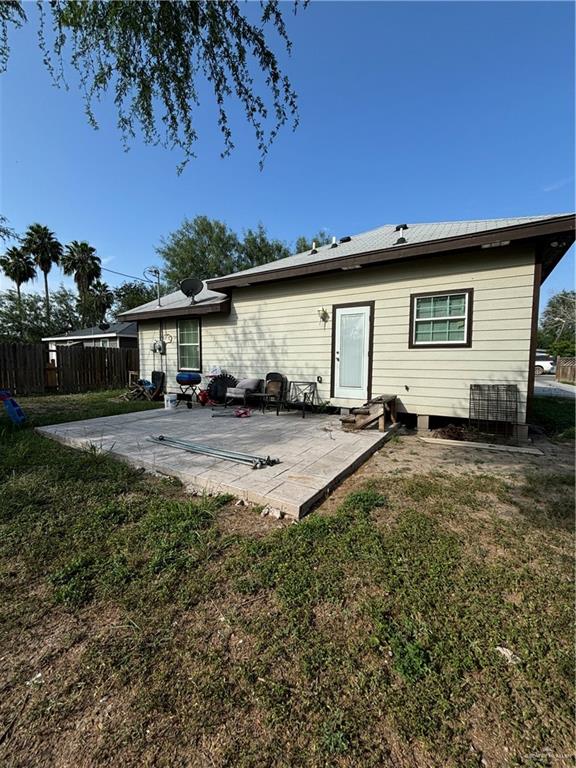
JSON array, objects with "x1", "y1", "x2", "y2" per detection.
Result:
[{"x1": 121, "y1": 214, "x2": 575, "y2": 426}]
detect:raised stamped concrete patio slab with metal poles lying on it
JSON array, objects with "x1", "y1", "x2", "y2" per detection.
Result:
[{"x1": 38, "y1": 407, "x2": 388, "y2": 518}]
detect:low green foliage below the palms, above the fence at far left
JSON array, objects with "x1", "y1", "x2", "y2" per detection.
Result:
[{"x1": 0, "y1": 287, "x2": 81, "y2": 342}]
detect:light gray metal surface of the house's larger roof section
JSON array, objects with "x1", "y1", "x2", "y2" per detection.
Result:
[{"x1": 210, "y1": 214, "x2": 570, "y2": 285}]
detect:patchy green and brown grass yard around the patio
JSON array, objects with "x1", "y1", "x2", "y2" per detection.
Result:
[{"x1": 0, "y1": 393, "x2": 574, "y2": 768}]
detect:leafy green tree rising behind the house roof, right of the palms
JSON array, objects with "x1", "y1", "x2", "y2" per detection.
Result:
[{"x1": 156, "y1": 216, "x2": 290, "y2": 287}]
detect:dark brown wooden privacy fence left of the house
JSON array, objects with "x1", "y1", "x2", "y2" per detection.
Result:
[{"x1": 0, "y1": 344, "x2": 138, "y2": 395}]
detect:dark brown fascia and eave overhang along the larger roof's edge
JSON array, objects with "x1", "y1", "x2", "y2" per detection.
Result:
[{"x1": 207, "y1": 214, "x2": 575, "y2": 291}]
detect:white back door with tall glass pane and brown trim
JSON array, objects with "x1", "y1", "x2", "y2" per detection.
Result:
[{"x1": 332, "y1": 305, "x2": 371, "y2": 402}]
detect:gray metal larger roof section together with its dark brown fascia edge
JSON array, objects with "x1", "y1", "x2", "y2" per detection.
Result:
[{"x1": 208, "y1": 214, "x2": 574, "y2": 288}]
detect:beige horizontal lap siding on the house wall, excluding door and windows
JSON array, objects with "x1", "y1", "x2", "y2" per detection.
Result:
[{"x1": 135, "y1": 249, "x2": 534, "y2": 417}]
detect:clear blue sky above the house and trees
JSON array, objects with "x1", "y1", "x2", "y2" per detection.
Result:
[{"x1": 0, "y1": 2, "x2": 575, "y2": 310}]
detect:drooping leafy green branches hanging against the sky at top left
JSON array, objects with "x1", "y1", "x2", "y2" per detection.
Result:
[{"x1": 0, "y1": 0, "x2": 298, "y2": 172}]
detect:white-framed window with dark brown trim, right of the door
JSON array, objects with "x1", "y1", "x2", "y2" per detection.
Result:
[{"x1": 410, "y1": 288, "x2": 473, "y2": 347}]
